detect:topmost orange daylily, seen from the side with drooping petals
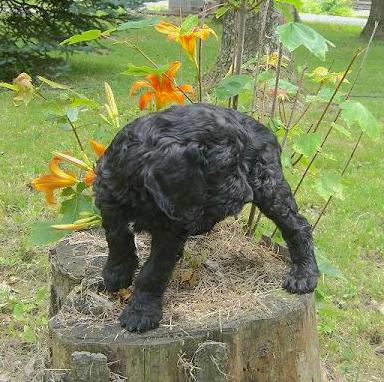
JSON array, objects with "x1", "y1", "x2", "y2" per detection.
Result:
[{"x1": 155, "y1": 21, "x2": 217, "y2": 66}]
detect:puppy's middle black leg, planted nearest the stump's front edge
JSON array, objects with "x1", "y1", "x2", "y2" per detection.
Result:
[{"x1": 120, "y1": 231, "x2": 186, "y2": 332}]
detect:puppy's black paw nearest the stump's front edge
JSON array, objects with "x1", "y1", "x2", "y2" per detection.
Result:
[{"x1": 119, "y1": 297, "x2": 163, "y2": 333}]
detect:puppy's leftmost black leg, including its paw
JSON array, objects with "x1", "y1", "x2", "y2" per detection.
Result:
[{"x1": 101, "y1": 208, "x2": 138, "y2": 292}]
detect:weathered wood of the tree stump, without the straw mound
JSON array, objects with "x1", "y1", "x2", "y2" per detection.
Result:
[{"x1": 49, "y1": 227, "x2": 321, "y2": 382}]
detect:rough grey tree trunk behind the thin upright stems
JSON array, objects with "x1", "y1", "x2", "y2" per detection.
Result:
[{"x1": 206, "y1": 1, "x2": 280, "y2": 85}]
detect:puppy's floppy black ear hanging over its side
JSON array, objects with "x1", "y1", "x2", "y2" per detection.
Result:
[{"x1": 144, "y1": 143, "x2": 207, "y2": 221}]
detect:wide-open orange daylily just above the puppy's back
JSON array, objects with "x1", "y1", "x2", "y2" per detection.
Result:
[{"x1": 130, "y1": 61, "x2": 194, "y2": 110}]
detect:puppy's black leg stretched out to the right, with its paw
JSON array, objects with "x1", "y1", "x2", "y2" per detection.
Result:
[{"x1": 254, "y1": 162, "x2": 319, "y2": 294}]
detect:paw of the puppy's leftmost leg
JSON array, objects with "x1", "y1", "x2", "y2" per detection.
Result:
[{"x1": 103, "y1": 261, "x2": 137, "y2": 292}]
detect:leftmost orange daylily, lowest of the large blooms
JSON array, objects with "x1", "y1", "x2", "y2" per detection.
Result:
[{"x1": 32, "y1": 156, "x2": 77, "y2": 204}]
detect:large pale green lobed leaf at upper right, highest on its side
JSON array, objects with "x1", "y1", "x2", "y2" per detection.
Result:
[{"x1": 276, "y1": 22, "x2": 334, "y2": 60}]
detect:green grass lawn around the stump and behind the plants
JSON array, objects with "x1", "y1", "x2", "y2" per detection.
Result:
[{"x1": 0, "y1": 20, "x2": 384, "y2": 381}]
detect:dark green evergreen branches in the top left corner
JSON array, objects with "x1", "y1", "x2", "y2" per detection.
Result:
[{"x1": 0, "y1": 0, "x2": 146, "y2": 79}]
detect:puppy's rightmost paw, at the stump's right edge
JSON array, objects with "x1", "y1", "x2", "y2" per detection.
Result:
[{"x1": 283, "y1": 266, "x2": 320, "y2": 294}]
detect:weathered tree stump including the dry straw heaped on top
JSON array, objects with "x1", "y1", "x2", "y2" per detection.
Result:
[{"x1": 49, "y1": 221, "x2": 321, "y2": 382}]
